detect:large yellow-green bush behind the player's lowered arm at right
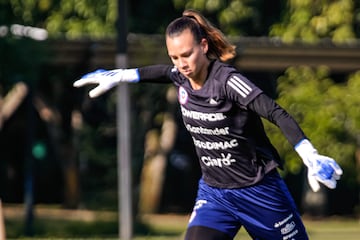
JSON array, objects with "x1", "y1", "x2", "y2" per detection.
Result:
[{"x1": 266, "y1": 66, "x2": 360, "y2": 188}]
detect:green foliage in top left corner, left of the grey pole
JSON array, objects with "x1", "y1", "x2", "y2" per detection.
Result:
[{"x1": 0, "y1": 0, "x2": 117, "y2": 39}]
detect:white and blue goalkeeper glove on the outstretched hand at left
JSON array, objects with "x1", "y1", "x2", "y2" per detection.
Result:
[{"x1": 73, "y1": 68, "x2": 140, "y2": 98}]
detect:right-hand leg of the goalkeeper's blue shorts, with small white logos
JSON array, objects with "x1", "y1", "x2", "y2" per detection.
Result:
[{"x1": 236, "y1": 170, "x2": 308, "y2": 240}]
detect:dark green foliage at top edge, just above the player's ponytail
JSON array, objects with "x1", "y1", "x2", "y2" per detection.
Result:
[{"x1": 173, "y1": 0, "x2": 283, "y2": 36}]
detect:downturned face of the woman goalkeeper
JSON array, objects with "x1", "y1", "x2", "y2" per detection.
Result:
[{"x1": 166, "y1": 29, "x2": 209, "y2": 82}]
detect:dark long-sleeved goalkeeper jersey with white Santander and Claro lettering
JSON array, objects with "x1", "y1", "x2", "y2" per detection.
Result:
[{"x1": 139, "y1": 61, "x2": 305, "y2": 188}]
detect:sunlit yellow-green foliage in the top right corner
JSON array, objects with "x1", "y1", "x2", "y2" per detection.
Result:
[{"x1": 270, "y1": 0, "x2": 356, "y2": 43}]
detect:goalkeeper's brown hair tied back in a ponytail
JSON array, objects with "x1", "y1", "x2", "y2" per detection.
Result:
[{"x1": 166, "y1": 9, "x2": 236, "y2": 62}]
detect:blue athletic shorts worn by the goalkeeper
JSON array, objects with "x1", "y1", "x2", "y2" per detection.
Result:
[{"x1": 188, "y1": 171, "x2": 308, "y2": 240}]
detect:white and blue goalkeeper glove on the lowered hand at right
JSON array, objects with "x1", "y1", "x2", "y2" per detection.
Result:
[{"x1": 295, "y1": 139, "x2": 343, "y2": 192}]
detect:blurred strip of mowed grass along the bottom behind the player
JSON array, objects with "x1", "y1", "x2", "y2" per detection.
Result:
[{"x1": 4, "y1": 205, "x2": 360, "y2": 240}]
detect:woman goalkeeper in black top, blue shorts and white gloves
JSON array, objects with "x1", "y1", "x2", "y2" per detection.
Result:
[{"x1": 74, "y1": 10, "x2": 342, "y2": 240}]
